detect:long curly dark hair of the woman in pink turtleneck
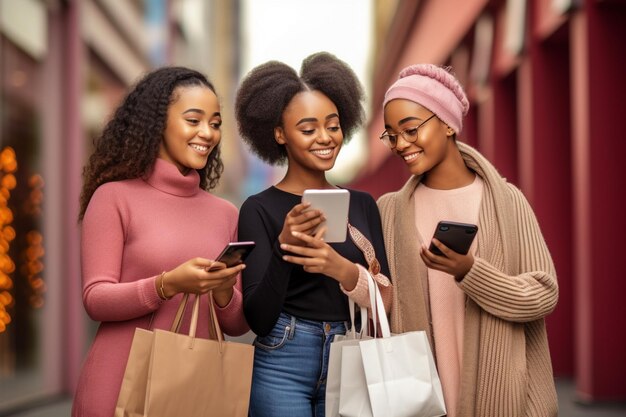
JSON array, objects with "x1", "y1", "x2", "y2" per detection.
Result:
[{"x1": 78, "y1": 67, "x2": 224, "y2": 221}]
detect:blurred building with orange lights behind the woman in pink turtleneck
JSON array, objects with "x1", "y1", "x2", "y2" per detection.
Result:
[{"x1": 0, "y1": 0, "x2": 238, "y2": 415}]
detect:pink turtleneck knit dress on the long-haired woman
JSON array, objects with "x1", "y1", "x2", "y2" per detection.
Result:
[{"x1": 72, "y1": 159, "x2": 248, "y2": 417}]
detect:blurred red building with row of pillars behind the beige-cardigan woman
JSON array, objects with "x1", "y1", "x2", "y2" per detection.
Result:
[{"x1": 351, "y1": 0, "x2": 626, "y2": 401}]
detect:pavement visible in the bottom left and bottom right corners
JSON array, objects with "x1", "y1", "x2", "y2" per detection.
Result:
[{"x1": 11, "y1": 379, "x2": 626, "y2": 417}]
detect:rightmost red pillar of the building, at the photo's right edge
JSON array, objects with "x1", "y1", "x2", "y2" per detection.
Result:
[{"x1": 571, "y1": 1, "x2": 626, "y2": 399}]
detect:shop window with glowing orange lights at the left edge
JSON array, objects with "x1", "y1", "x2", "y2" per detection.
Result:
[{"x1": 0, "y1": 32, "x2": 46, "y2": 411}]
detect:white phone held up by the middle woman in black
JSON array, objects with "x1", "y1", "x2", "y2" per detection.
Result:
[{"x1": 302, "y1": 189, "x2": 350, "y2": 243}]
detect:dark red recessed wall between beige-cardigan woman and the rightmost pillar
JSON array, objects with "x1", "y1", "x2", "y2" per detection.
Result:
[{"x1": 518, "y1": 3, "x2": 574, "y2": 376}]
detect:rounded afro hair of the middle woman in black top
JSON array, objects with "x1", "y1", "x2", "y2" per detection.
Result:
[{"x1": 235, "y1": 52, "x2": 365, "y2": 165}]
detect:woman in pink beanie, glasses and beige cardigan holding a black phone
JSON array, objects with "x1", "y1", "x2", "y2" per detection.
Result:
[{"x1": 378, "y1": 64, "x2": 558, "y2": 417}]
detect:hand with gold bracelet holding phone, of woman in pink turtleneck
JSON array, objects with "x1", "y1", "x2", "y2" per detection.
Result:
[{"x1": 157, "y1": 258, "x2": 246, "y2": 298}]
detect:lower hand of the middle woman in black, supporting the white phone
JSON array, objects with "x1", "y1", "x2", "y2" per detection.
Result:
[{"x1": 280, "y1": 228, "x2": 359, "y2": 291}]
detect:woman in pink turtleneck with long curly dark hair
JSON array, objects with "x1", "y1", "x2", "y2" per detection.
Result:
[{"x1": 72, "y1": 67, "x2": 248, "y2": 417}]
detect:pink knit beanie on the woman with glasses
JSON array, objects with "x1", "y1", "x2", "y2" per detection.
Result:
[{"x1": 383, "y1": 64, "x2": 469, "y2": 133}]
